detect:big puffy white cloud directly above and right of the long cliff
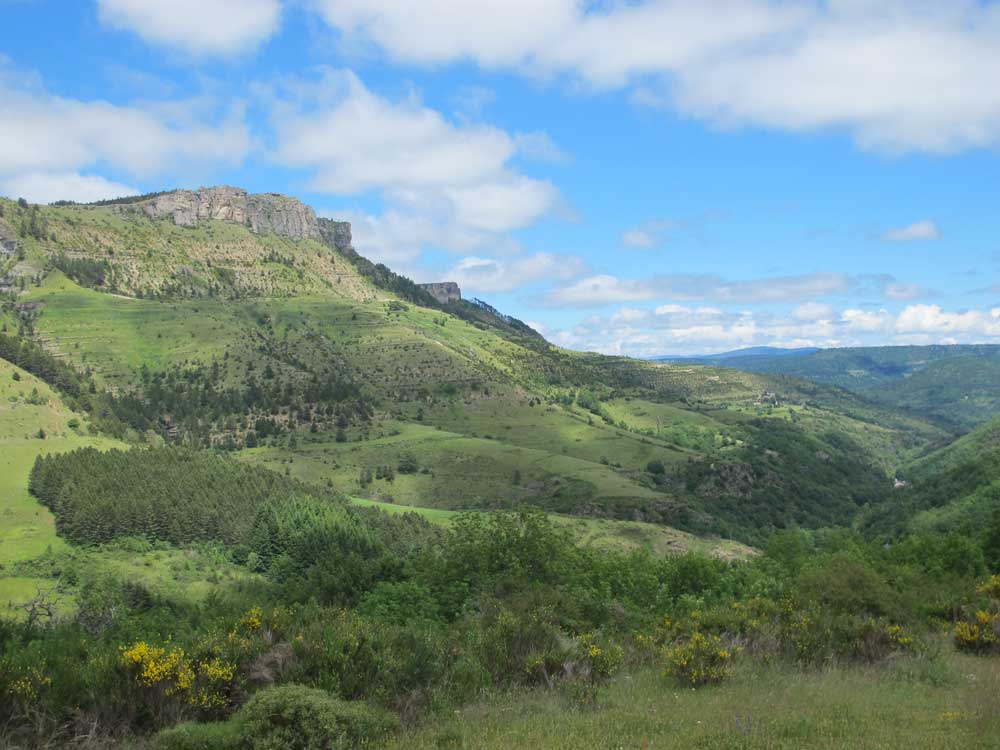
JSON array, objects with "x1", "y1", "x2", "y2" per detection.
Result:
[{"x1": 270, "y1": 69, "x2": 560, "y2": 256}]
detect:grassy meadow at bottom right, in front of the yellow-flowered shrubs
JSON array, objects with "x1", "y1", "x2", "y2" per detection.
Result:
[{"x1": 389, "y1": 654, "x2": 1000, "y2": 750}]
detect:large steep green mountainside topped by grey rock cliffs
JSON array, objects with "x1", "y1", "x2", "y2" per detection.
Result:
[{"x1": 0, "y1": 188, "x2": 946, "y2": 540}]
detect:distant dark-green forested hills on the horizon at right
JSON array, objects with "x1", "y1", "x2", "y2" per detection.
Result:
[{"x1": 664, "y1": 344, "x2": 1000, "y2": 432}]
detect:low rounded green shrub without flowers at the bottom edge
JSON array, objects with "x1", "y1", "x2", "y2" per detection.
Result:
[{"x1": 236, "y1": 685, "x2": 397, "y2": 750}]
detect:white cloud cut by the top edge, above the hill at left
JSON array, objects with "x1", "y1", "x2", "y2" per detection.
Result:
[{"x1": 97, "y1": 0, "x2": 281, "y2": 56}]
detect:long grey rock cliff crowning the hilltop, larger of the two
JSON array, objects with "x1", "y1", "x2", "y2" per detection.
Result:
[{"x1": 113, "y1": 186, "x2": 351, "y2": 250}]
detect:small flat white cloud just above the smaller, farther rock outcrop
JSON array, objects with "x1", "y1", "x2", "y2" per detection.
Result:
[{"x1": 444, "y1": 253, "x2": 586, "y2": 292}]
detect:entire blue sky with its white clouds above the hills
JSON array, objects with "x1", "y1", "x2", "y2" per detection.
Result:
[{"x1": 0, "y1": 0, "x2": 1000, "y2": 356}]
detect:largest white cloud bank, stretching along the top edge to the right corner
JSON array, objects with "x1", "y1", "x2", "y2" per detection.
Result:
[{"x1": 312, "y1": 0, "x2": 1000, "y2": 152}]
